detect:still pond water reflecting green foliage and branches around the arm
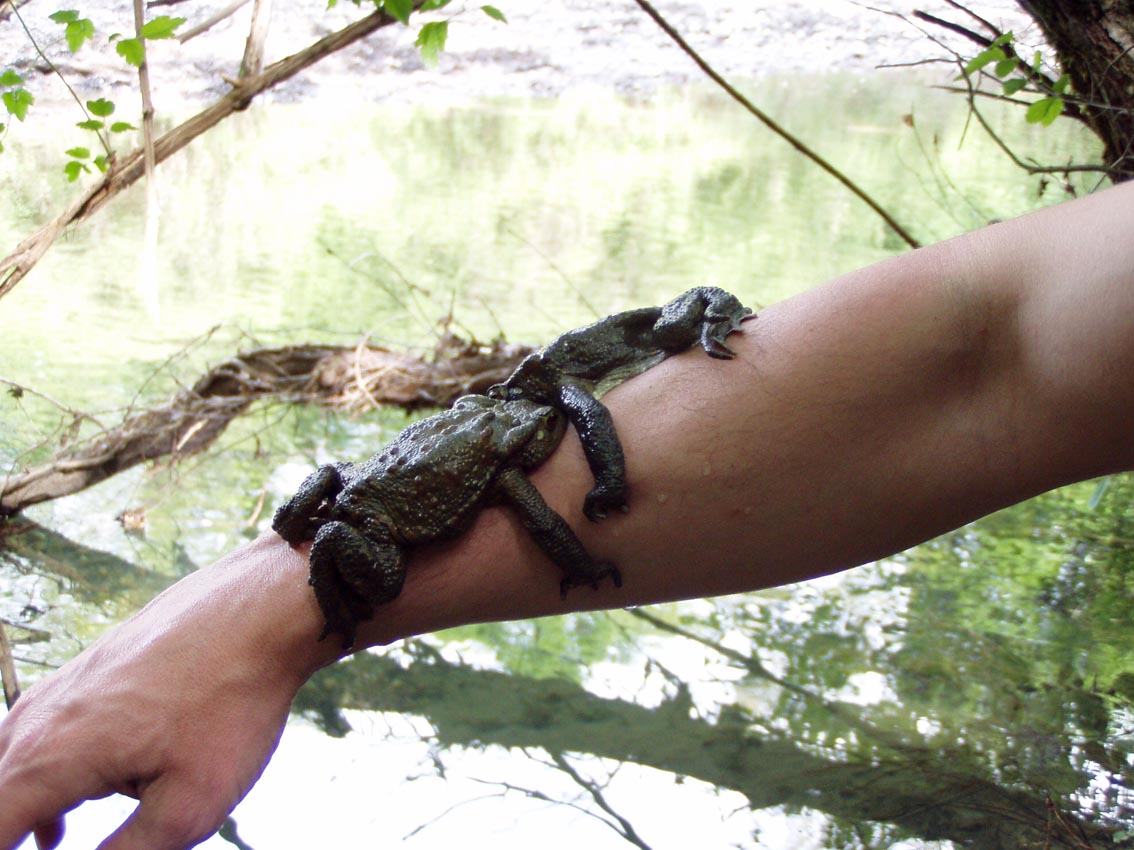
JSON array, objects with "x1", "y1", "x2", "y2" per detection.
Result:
[{"x1": 0, "y1": 68, "x2": 1134, "y2": 850}]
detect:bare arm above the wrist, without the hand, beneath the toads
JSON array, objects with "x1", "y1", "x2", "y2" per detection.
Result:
[{"x1": 344, "y1": 187, "x2": 1134, "y2": 641}]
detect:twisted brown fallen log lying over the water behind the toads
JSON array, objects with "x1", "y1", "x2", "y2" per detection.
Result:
[{"x1": 0, "y1": 334, "x2": 533, "y2": 516}]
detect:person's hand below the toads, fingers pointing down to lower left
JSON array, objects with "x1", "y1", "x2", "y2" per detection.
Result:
[{"x1": 0, "y1": 536, "x2": 328, "y2": 850}]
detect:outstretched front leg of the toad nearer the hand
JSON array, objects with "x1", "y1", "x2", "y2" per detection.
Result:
[{"x1": 497, "y1": 467, "x2": 623, "y2": 596}]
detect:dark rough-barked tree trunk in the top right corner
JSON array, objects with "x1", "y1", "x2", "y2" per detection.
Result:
[{"x1": 1018, "y1": 0, "x2": 1134, "y2": 176}]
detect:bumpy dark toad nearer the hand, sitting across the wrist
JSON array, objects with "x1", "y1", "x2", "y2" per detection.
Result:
[{"x1": 272, "y1": 396, "x2": 621, "y2": 648}]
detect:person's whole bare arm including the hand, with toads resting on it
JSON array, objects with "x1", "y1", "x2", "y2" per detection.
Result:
[{"x1": 0, "y1": 185, "x2": 1134, "y2": 850}]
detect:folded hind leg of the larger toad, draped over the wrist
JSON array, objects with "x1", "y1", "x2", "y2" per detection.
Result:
[{"x1": 307, "y1": 521, "x2": 406, "y2": 649}]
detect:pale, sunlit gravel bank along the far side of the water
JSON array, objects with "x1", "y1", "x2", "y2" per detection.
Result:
[{"x1": 0, "y1": 0, "x2": 1034, "y2": 109}]
